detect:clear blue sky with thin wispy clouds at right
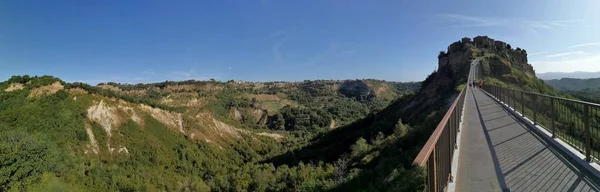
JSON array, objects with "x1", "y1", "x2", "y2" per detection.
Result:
[{"x1": 0, "y1": 0, "x2": 600, "y2": 84}]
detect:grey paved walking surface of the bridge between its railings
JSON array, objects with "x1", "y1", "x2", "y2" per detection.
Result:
[{"x1": 456, "y1": 89, "x2": 600, "y2": 191}]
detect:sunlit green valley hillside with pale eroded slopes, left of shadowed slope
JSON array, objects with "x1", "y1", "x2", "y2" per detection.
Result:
[{"x1": 0, "y1": 76, "x2": 419, "y2": 191}]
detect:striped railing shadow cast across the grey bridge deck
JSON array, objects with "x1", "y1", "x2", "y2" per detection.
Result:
[{"x1": 471, "y1": 89, "x2": 600, "y2": 191}]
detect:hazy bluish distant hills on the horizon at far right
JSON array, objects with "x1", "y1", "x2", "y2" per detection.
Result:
[{"x1": 545, "y1": 78, "x2": 600, "y2": 91}]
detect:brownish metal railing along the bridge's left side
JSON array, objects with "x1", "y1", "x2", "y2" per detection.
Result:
[{"x1": 413, "y1": 86, "x2": 467, "y2": 191}]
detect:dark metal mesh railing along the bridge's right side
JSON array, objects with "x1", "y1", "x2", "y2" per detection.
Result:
[{"x1": 483, "y1": 85, "x2": 600, "y2": 162}]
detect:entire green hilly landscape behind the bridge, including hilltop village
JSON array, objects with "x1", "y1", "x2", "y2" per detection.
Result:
[{"x1": 0, "y1": 36, "x2": 556, "y2": 191}]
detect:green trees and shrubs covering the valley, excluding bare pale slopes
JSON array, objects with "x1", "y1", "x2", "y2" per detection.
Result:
[{"x1": 0, "y1": 76, "x2": 433, "y2": 191}]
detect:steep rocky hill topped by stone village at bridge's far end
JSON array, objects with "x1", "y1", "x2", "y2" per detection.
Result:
[{"x1": 401, "y1": 36, "x2": 535, "y2": 123}]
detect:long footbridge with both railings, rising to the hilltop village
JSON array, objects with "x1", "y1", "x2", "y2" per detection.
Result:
[{"x1": 413, "y1": 58, "x2": 600, "y2": 191}]
